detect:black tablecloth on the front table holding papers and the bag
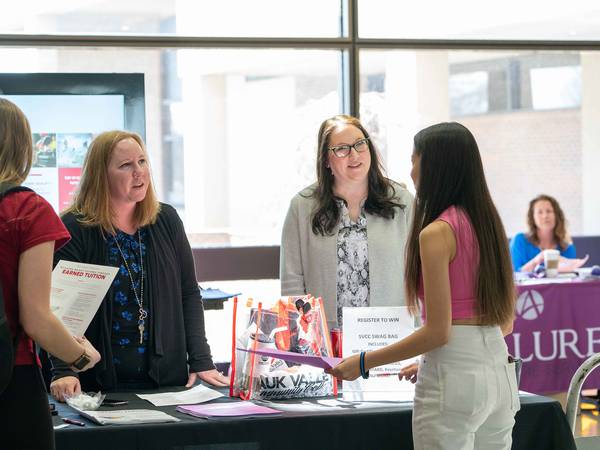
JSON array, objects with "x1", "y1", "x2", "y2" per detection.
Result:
[{"x1": 54, "y1": 391, "x2": 575, "y2": 450}]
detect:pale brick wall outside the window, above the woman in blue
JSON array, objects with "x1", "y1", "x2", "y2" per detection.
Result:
[{"x1": 458, "y1": 109, "x2": 582, "y2": 236}]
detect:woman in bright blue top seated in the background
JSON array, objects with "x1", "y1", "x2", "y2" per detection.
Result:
[{"x1": 510, "y1": 194, "x2": 587, "y2": 272}]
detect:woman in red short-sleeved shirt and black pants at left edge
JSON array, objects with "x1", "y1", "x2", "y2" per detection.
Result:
[{"x1": 0, "y1": 98, "x2": 100, "y2": 449}]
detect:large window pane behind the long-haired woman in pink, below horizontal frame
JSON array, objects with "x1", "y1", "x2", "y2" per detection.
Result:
[{"x1": 360, "y1": 50, "x2": 600, "y2": 235}]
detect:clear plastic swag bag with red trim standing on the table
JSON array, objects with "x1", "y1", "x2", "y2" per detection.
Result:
[{"x1": 230, "y1": 296, "x2": 337, "y2": 400}]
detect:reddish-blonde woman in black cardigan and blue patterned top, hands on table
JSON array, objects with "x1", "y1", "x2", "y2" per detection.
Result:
[{"x1": 50, "y1": 131, "x2": 228, "y2": 400}]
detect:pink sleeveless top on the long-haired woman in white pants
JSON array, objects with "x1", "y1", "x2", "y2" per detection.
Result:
[{"x1": 418, "y1": 206, "x2": 479, "y2": 322}]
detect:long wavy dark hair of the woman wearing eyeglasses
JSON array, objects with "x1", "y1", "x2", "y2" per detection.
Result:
[{"x1": 308, "y1": 114, "x2": 406, "y2": 236}]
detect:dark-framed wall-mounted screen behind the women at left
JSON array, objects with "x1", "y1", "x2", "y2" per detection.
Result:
[{"x1": 0, "y1": 74, "x2": 145, "y2": 212}]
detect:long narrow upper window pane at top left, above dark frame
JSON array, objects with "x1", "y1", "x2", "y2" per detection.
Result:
[{"x1": 0, "y1": 0, "x2": 342, "y2": 38}]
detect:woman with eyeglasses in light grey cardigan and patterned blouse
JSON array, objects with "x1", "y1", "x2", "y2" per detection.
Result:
[{"x1": 280, "y1": 115, "x2": 413, "y2": 326}]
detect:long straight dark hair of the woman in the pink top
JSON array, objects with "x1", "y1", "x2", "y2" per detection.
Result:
[{"x1": 405, "y1": 122, "x2": 516, "y2": 325}]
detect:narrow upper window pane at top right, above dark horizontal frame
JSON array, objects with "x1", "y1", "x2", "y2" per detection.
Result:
[{"x1": 358, "y1": 0, "x2": 600, "y2": 41}]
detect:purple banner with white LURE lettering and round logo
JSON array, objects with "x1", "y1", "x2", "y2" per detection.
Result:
[{"x1": 506, "y1": 280, "x2": 600, "y2": 394}]
